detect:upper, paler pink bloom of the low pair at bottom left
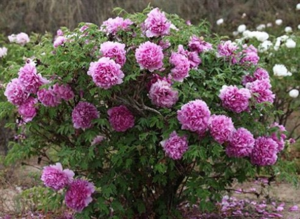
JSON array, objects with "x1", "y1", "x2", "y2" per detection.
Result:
[{"x1": 41, "y1": 163, "x2": 75, "y2": 191}]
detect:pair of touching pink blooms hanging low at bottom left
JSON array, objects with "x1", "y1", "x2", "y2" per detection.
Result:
[{"x1": 41, "y1": 163, "x2": 95, "y2": 212}]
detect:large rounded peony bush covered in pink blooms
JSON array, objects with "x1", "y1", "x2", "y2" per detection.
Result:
[{"x1": 0, "y1": 8, "x2": 292, "y2": 218}]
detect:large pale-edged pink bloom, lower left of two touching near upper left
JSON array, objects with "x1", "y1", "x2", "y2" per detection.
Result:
[{"x1": 87, "y1": 57, "x2": 124, "y2": 89}]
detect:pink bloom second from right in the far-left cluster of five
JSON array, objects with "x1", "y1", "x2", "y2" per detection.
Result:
[{"x1": 37, "y1": 88, "x2": 61, "y2": 107}]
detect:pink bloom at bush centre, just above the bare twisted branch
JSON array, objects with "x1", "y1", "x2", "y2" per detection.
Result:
[{"x1": 149, "y1": 80, "x2": 178, "y2": 108}]
